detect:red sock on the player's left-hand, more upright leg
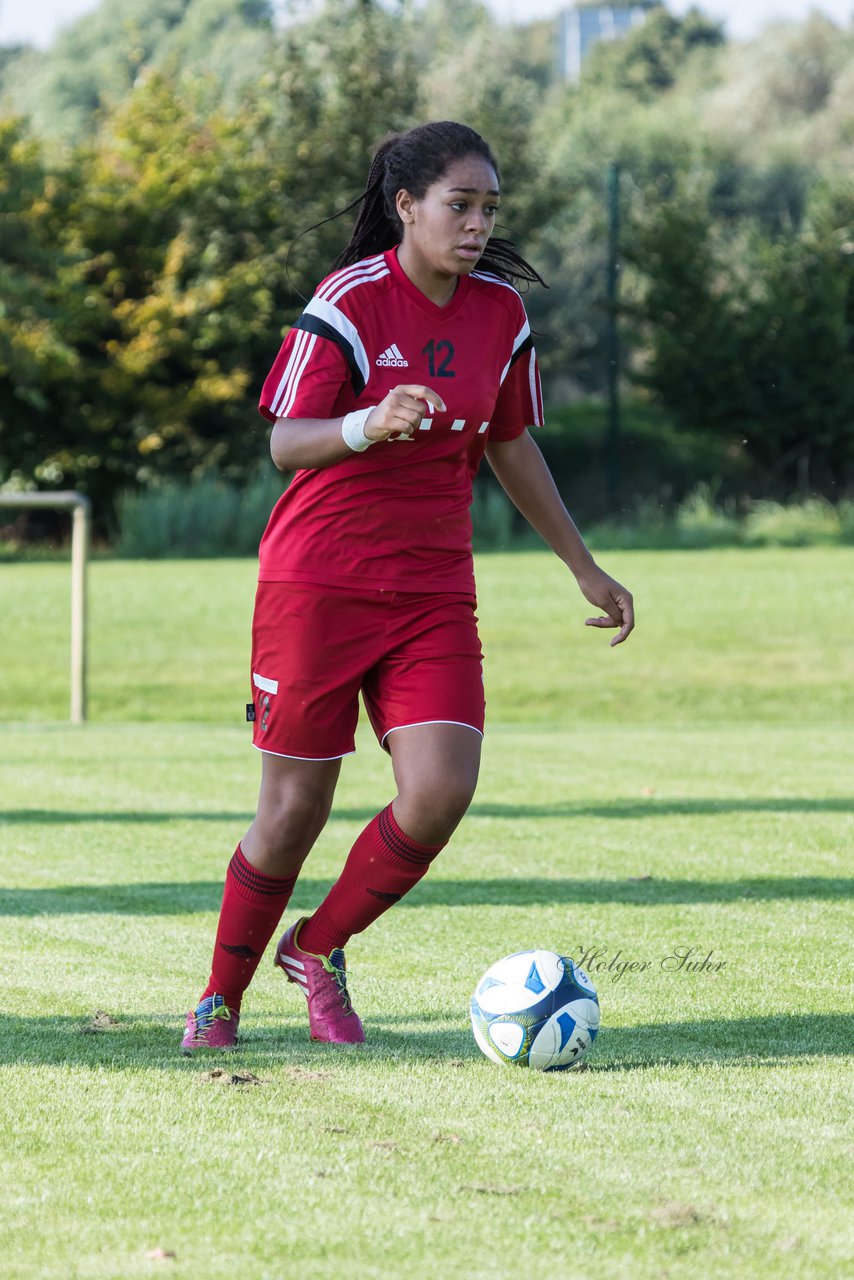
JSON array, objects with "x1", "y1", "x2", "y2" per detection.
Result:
[{"x1": 201, "y1": 845, "x2": 297, "y2": 1012}]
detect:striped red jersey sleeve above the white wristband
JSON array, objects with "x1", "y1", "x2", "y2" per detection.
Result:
[{"x1": 259, "y1": 321, "x2": 350, "y2": 422}]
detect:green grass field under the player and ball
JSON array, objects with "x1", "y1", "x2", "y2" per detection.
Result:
[{"x1": 0, "y1": 549, "x2": 854, "y2": 1280}]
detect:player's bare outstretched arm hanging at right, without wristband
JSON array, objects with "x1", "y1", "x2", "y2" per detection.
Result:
[{"x1": 487, "y1": 431, "x2": 635, "y2": 646}]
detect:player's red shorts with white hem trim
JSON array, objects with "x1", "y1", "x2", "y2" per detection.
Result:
[{"x1": 252, "y1": 582, "x2": 484, "y2": 760}]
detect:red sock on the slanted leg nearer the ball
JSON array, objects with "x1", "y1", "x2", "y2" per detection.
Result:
[{"x1": 300, "y1": 805, "x2": 444, "y2": 955}]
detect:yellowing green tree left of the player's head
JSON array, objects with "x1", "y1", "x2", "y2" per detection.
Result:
[{"x1": 2, "y1": 3, "x2": 417, "y2": 520}]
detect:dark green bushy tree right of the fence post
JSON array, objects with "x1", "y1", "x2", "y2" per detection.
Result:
[{"x1": 629, "y1": 170, "x2": 854, "y2": 495}]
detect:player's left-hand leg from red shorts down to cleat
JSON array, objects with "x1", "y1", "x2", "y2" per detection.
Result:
[{"x1": 182, "y1": 582, "x2": 361, "y2": 1052}]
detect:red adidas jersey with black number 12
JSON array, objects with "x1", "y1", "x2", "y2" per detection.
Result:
[{"x1": 259, "y1": 250, "x2": 543, "y2": 595}]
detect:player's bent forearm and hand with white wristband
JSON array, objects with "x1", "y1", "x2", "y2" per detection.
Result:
[{"x1": 270, "y1": 385, "x2": 444, "y2": 471}]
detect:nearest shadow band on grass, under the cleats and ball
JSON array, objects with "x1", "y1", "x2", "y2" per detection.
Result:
[{"x1": 0, "y1": 1010, "x2": 853, "y2": 1085}]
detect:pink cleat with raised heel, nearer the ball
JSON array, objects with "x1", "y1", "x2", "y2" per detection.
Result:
[{"x1": 275, "y1": 916, "x2": 365, "y2": 1044}]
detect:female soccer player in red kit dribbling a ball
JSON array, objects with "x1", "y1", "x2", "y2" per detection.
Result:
[{"x1": 182, "y1": 122, "x2": 634, "y2": 1053}]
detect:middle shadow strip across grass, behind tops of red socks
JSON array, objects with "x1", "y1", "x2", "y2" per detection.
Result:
[{"x1": 0, "y1": 876, "x2": 854, "y2": 916}]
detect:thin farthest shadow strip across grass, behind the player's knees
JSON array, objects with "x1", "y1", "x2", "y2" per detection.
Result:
[{"x1": 0, "y1": 796, "x2": 854, "y2": 826}]
